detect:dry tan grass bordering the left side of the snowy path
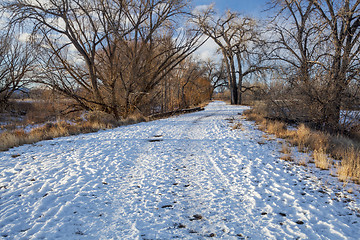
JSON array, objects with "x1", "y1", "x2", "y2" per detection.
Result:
[{"x1": 0, "y1": 98, "x2": 207, "y2": 151}]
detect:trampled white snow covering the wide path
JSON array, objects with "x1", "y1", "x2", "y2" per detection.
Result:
[{"x1": 0, "y1": 102, "x2": 360, "y2": 239}]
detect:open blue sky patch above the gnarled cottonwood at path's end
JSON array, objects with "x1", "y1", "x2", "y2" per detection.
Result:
[{"x1": 193, "y1": 0, "x2": 268, "y2": 17}]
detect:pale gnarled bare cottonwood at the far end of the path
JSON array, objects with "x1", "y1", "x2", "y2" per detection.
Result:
[{"x1": 194, "y1": 8, "x2": 268, "y2": 104}]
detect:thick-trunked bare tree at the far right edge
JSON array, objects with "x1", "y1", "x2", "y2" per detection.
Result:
[{"x1": 310, "y1": 0, "x2": 360, "y2": 128}]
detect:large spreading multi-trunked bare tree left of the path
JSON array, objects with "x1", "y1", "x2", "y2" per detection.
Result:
[{"x1": 3, "y1": 0, "x2": 199, "y2": 118}]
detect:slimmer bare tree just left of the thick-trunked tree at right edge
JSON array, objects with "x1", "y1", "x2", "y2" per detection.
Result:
[{"x1": 269, "y1": 0, "x2": 327, "y2": 122}]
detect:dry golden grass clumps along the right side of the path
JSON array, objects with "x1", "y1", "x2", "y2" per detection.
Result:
[{"x1": 244, "y1": 110, "x2": 360, "y2": 184}]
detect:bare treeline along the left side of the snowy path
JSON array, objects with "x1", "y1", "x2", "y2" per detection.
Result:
[{"x1": 0, "y1": 0, "x2": 211, "y2": 119}]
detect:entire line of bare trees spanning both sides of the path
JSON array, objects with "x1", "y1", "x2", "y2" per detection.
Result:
[{"x1": 0, "y1": 0, "x2": 360, "y2": 130}]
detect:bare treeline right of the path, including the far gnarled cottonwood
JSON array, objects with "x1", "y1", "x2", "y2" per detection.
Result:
[{"x1": 194, "y1": 0, "x2": 360, "y2": 131}]
